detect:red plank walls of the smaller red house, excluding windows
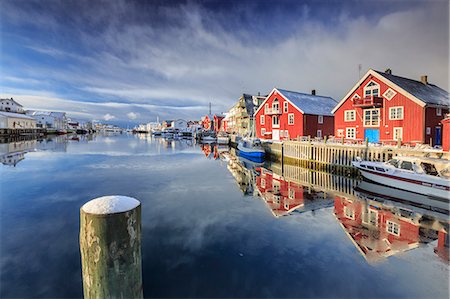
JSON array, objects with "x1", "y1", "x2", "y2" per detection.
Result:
[{"x1": 255, "y1": 91, "x2": 334, "y2": 140}]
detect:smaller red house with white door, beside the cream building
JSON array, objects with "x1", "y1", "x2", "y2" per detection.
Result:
[{"x1": 255, "y1": 88, "x2": 336, "y2": 140}]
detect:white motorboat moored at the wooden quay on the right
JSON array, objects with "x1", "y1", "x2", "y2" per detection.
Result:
[{"x1": 352, "y1": 157, "x2": 450, "y2": 205}]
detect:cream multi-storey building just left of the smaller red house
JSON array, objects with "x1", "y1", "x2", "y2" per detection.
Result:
[{"x1": 225, "y1": 93, "x2": 266, "y2": 136}]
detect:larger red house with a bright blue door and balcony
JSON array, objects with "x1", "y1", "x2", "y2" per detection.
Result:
[{"x1": 332, "y1": 69, "x2": 450, "y2": 145}]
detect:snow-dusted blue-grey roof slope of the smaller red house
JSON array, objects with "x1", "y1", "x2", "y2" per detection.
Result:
[{"x1": 277, "y1": 88, "x2": 337, "y2": 115}]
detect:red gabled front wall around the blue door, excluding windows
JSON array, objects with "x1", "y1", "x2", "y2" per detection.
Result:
[{"x1": 334, "y1": 75, "x2": 425, "y2": 143}]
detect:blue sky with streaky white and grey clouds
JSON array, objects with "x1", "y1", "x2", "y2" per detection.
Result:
[{"x1": 0, "y1": 0, "x2": 450, "y2": 127}]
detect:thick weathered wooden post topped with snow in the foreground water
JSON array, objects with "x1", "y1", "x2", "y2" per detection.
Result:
[{"x1": 80, "y1": 195, "x2": 143, "y2": 298}]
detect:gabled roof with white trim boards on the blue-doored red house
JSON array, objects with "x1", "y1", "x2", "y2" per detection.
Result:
[{"x1": 332, "y1": 69, "x2": 450, "y2": 113}]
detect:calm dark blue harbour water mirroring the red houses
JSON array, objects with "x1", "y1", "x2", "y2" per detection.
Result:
[{"x1": 0, "y1": 135, "x2": 449, "y2": 298}]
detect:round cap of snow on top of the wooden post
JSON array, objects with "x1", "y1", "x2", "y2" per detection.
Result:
[{"x1": 81, "y1": 195, "x2": 141, "y2": 215}]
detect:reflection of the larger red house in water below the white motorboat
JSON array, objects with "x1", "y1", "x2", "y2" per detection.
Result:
[{"x1": 334, "y1": 196, "x2": 448, "y2": 262}]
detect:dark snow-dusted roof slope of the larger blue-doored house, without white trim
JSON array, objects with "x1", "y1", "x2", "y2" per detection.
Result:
[{"x1": 375, "y1": 71, "x2": 450, "y2": 106}]
